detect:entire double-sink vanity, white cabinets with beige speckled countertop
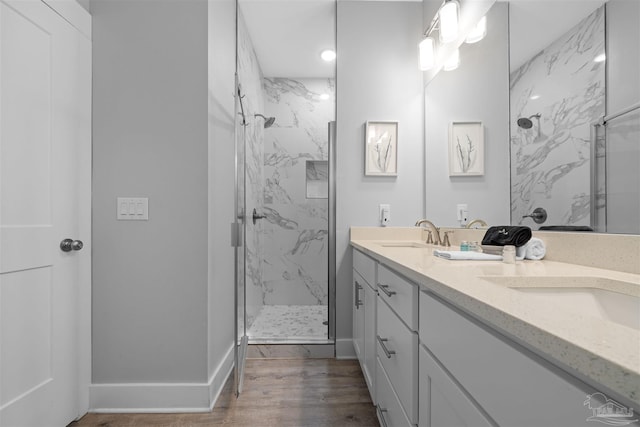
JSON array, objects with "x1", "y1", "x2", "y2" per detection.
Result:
[{"x1": 351, "y1": 228, "x2": 640, "y2": 427}]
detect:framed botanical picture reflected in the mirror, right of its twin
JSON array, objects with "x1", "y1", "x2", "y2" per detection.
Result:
[{"x1": 449, "y1": 122, "x2": 484, "y2": 176}]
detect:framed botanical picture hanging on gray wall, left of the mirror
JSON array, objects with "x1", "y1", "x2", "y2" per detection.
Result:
[{"x1": 364, "y1": 121, "x2": 398, "y2": 176}]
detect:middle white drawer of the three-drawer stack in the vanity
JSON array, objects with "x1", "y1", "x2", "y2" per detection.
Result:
[{"x1": 376, "y1": 300, "x2": 418, "y2": 423}]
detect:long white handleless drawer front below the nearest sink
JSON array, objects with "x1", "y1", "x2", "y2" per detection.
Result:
[{"x1": 420, "y1": 292, "x2": 597, "y2": 427}]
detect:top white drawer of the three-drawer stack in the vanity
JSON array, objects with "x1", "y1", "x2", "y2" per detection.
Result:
[{"x1": 378, "y1": 265, "x2": 418, "y2": 331}]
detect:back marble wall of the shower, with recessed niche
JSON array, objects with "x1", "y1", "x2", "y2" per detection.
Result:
[{"x1": 263, "y1": 78, "x2": 335, "y2": 305}]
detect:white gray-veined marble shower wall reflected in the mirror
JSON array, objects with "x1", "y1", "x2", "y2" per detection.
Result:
[{"x1": 510, "y1": 7, "x2": 605, "y2": 225}]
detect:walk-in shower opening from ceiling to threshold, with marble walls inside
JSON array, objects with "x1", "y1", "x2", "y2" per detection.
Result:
[{"x1": 237, "y1": 0, "x2": 336, "y2": 344}]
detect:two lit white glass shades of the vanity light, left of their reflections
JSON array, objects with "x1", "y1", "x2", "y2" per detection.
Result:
[{"x1": 418, "y1": 0, "x2": 460, "y2": 71}]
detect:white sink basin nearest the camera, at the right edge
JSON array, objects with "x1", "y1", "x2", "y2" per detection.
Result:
[{"x1": 481, "y1": 276, "x2": 640, "y2": 331}]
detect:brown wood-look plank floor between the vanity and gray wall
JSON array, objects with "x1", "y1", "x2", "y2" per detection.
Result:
[{"x1": 69, "y1": 359, "x2": 378, "y2": 427}]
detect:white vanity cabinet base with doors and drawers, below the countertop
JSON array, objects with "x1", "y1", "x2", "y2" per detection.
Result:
[{"x1": 354, "y1": 246, "x2": 624, "y2": 427}]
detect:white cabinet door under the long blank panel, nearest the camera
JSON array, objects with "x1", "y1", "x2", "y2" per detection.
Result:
[{"x1": 418, "y1": 346, "x2": 493, "y2": 427}]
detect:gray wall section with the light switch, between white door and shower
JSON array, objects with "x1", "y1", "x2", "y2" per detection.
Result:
[{"x1": 91, "y1": 0, "x2": 208, "y2": 383}]
